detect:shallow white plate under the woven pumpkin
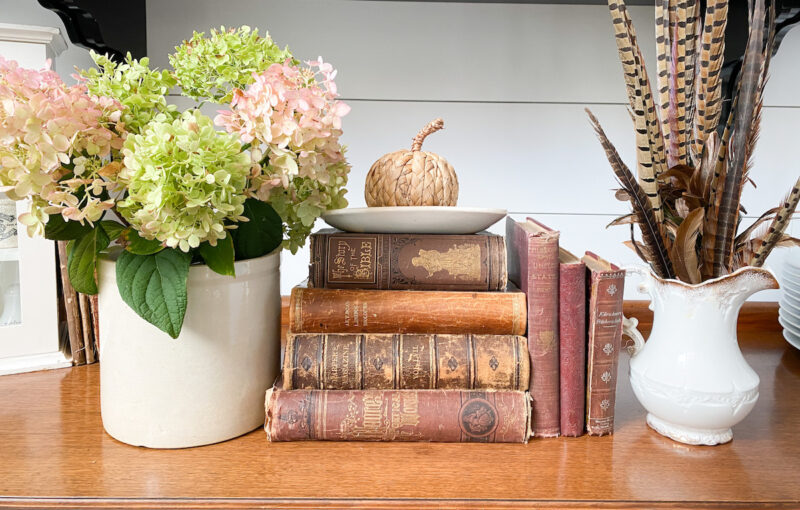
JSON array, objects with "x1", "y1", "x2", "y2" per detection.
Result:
[{"x1": 322, "y1": 206, "x2": 507, "y2": 234}]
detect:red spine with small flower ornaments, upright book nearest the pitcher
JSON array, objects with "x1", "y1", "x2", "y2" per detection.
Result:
[{"x1": 586, "y1": 271, "x2": 625, "y2": 436}]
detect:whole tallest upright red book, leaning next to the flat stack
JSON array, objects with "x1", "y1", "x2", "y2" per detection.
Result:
[{"x1": 506, "y1": 218, "x2": 561, "y2": 437}]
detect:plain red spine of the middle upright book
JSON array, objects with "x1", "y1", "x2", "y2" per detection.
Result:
[{"x1": 558, "y1": 263, "x2": 586, "y2": 437}]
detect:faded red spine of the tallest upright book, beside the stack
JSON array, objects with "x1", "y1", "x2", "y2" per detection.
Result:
[{"x1": 527, "y1": 232, "x2": 561, "y2": 437}]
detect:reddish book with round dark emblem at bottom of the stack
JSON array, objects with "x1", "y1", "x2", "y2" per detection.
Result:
[{"x1": 265, "y1": 389, "x2": 530, "y2": 443}]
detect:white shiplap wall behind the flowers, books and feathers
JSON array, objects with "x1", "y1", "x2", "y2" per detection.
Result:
[{"x1": 147, "y1": 0, "x2": 800, "y2": 299}]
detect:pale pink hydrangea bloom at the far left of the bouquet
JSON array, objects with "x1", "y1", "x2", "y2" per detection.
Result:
[{"x1": 0, "y1": 57, "x2": 125, "y2": 234}]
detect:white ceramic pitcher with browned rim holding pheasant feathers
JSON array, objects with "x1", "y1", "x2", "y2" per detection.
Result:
[{"x1": 623, "y1": 267, "x2": 778, "y2": 445}]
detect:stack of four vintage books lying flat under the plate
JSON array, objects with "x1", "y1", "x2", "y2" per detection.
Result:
[{"x1": 267, "y1": 230, "x2": 531, "y2": 442}]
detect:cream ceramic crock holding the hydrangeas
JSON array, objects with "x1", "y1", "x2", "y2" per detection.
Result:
[{"x1": 99, "y1": 249, "x2": 281, "y2": 448}]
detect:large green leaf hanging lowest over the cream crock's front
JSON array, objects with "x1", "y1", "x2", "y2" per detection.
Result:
[{"x1": 117, "y1": 249, "x2": 192, "y2": 338}]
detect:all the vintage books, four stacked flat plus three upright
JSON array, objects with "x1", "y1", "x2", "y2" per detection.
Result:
[{"x1": 266, "y1": 218, "x2": 625, "y2": 442}]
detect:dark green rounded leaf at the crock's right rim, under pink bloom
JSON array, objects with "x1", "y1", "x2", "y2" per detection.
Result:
[{"x1": 230, "y1": 198, "x2": 283, "y2": 260}]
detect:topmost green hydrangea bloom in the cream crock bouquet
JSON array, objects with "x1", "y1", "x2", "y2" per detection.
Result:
[{"x1": 169, "y1": 26, "x2": 292, "y2": 103}]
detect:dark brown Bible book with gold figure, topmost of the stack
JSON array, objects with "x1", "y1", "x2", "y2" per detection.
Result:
[{"x1": 308, "y1": 229, "x2": 507, "y2": 291}]
